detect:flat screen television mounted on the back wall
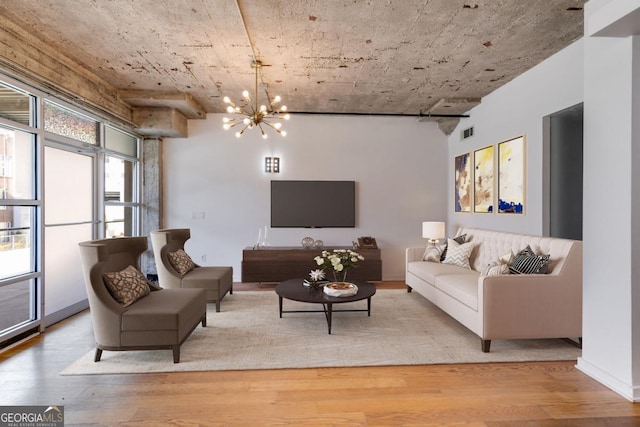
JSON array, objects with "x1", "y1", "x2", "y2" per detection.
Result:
[{"x1": 271, "y1": 181, "x2": 356, "y2": 228}]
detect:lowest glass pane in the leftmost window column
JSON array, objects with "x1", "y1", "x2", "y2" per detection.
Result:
[{"x1": 0, "y1": 280, "x2": 36, "y2": 333}]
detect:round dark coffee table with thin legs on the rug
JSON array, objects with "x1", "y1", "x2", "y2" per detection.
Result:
[{"x1": 276, "y1": 279, "x2": 376, "y2": 333}]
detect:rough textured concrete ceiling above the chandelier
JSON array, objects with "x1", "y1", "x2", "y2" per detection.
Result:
[{"x1": 0, "y1": 0, "x2": 585, "y2": 130}]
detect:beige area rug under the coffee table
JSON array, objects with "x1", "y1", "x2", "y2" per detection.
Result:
[{"x1": 61, "y1": 289, "x2": 581, "y2": 375}]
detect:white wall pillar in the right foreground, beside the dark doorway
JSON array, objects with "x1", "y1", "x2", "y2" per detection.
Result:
[{"x1": 578, "y1": 0, "x2": 640, "y2": 401}]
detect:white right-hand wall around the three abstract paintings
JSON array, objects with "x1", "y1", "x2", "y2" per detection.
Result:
[{"x1": 447, "y1": 40, "x2": 583, "y2": 235}]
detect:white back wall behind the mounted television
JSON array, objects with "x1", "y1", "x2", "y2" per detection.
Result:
[{"x1": 163, "y1": 114, "x2": 448, "y2": 281}]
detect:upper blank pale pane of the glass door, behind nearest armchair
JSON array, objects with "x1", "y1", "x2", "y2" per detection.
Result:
[{"x1": 44, "y1": 147, "x2": 94, "y2": 225}]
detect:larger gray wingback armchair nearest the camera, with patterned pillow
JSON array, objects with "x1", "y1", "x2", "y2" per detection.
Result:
[{"x1": 79, "y1": 237, "x2": 207, "y2": 363}]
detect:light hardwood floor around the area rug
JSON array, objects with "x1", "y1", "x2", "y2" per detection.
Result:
[{"x1": 0, "y1": 283, "x2": 640, "y2": 427}]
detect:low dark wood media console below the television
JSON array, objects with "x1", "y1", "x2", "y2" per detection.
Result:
[{"x1": 242, "y1": 246, "x2": 382, "y2": 283}]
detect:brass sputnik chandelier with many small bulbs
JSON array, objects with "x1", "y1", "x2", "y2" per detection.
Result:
[{"x1": 222, "y1": 60, "x2": 289, "y2": 139}]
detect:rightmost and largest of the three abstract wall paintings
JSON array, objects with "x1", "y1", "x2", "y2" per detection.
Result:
[{"x1": 498, "y1": 135, "x2": 525, "y2": 214}]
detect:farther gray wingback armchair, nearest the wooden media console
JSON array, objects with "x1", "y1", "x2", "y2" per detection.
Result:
[{"x1": 151, "y1": 228, "x2": 233, "y2": 312}]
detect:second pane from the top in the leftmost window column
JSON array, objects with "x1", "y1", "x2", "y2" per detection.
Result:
[{"x1": 0, "y1": 127, "x2": 35, "y2": 200}]
